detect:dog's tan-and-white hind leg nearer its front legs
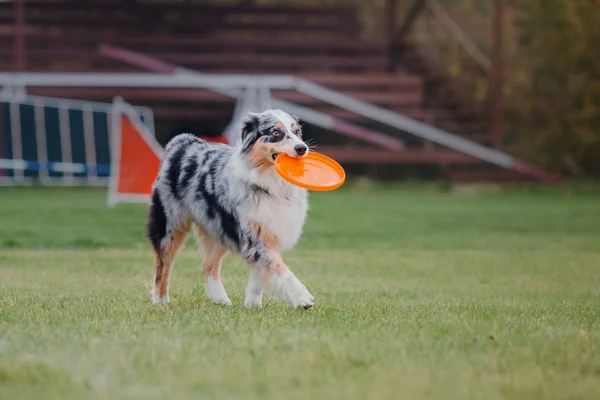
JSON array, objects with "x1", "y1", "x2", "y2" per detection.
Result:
[{"x1": 196, "y1": 225, "x2": 232, "y2": 306}]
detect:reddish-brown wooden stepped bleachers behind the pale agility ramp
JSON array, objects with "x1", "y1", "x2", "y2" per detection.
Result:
[{"x1": 0, "y1": 0, "x2": 520, "y2": 181}]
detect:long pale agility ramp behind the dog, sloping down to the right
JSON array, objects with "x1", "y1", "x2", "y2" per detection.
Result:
[{"x1": 0, "y1": 72, "x2": 558, "y2": 181}]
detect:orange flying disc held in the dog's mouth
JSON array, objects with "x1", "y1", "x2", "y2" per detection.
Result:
[{"x1": 275, "y1": 151, "x2": 346, "y2": 192}]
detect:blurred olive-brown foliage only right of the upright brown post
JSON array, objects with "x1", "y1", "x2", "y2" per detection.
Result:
[{"x1": 506, "y1": 0, "x2": 600, "y2": 176}]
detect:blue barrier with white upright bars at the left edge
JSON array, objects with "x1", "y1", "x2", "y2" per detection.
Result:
[{"x1": 0, "y1": 95, "x2": 154, "y2": 184}]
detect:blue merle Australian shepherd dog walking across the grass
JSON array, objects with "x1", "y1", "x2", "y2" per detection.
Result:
[{"x1": 146, "y1": 109, "x2": 314, "y2": 309}]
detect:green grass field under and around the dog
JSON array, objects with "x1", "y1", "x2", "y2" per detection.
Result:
[{"x1": 0, "y1": 186, "x2": 600, "y2": 400}]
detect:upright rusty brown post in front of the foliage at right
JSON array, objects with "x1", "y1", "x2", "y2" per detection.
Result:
[{"x1": 492, "y1": 0, "x2": 504, "y2": 149}]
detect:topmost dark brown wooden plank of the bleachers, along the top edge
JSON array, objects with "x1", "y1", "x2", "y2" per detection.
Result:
[{"x1": 0, "y1": 1, "x2": 359, "y2": 34}]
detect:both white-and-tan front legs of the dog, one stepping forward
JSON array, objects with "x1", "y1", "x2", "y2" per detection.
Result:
[{"x1": 244, "y1": 246, "x2": 315, "y2": 309}]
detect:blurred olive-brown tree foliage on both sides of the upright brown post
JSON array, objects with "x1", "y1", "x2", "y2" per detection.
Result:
[{"x1": 406, "y1": 0, "x2": 600, "y2": 177}]
